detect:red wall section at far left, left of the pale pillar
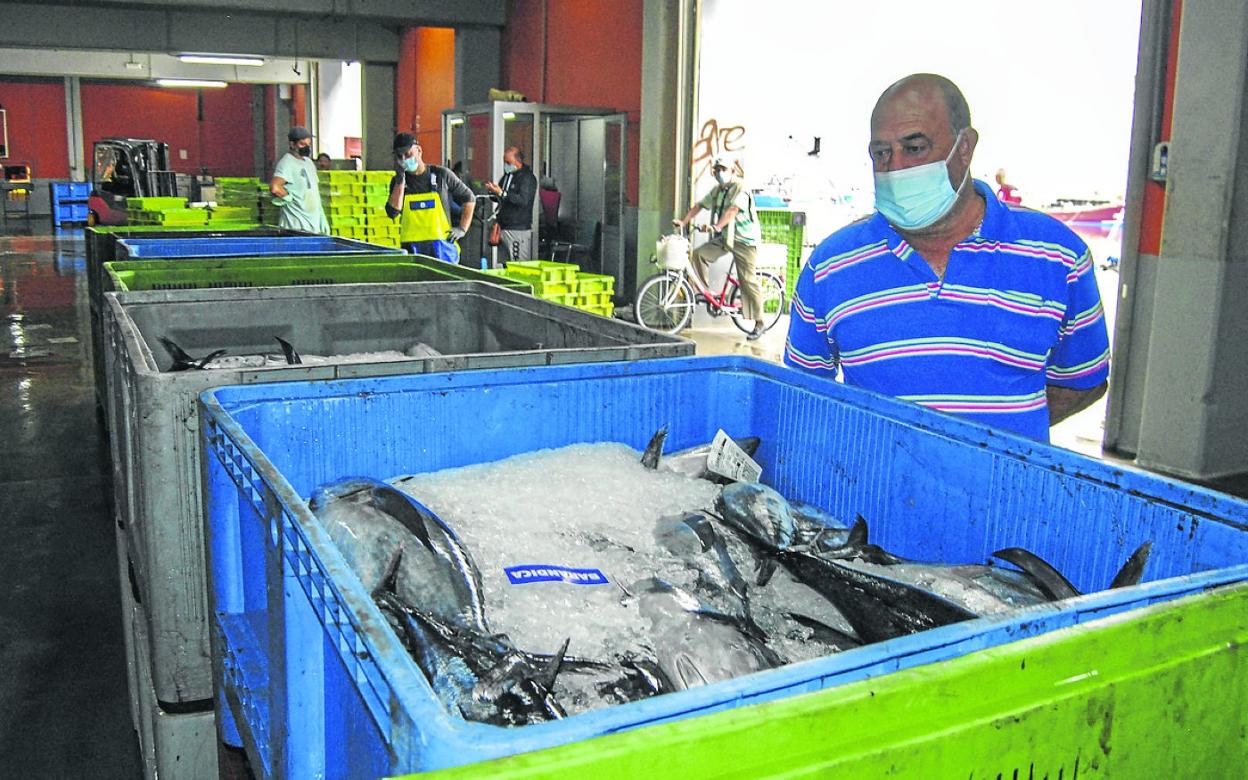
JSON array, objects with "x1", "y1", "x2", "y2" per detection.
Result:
[{"x1": 0, "y1": 80, "x2": 70, "y2": 178}]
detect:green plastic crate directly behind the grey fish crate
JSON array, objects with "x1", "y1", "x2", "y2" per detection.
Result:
[{"x1": 104, "y1": 252, "x2": 530, "y2": 293}]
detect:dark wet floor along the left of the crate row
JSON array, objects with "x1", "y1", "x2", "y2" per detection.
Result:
[{"x1": 0, "y1": 227, "x2": 141, "y2": 778}]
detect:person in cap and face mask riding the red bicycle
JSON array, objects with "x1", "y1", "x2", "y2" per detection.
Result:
[{"x1": 671, "y1": 155, "x2": 765, "y2": 341}]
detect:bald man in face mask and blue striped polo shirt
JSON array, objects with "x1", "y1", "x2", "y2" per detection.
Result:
[{"x1": 785, "y1": 74, "x2": 1109, "y2": 441}]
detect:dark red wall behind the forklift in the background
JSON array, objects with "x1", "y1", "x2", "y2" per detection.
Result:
[{"x1": 79, "y1": 81, "x2": 252, "y2": 176}]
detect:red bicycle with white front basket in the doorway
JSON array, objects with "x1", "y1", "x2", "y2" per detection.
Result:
[{"x1": 633, "y1": 228, "x2": 785, "y2": 333}]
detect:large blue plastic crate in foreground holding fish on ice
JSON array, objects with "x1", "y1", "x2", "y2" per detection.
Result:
[{"x1": 201, "y1": 358, "x2": 1248, "y2": 778}]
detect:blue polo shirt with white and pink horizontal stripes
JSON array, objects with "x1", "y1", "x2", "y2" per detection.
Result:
[{"x1": 785, "y1": 181, "x2": 1109, "y2": 442}]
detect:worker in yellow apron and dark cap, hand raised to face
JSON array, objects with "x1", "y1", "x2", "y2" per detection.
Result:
[{"x1": 386, "y1": 132, "x2": 477, "y2": 263}]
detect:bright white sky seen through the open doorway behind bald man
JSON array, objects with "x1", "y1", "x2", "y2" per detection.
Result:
[{"x1": 695, "y1": 0, "x2": 1141, "y2": 208}]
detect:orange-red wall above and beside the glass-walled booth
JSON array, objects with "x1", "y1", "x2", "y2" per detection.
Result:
[{"x1": 499, "y1": 0, "x2": 643, "y2": 206}]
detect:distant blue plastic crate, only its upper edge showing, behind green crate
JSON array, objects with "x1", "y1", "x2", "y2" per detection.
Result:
[{"x1": 116, "y1": 236, "x2": 394, "y2": 260}]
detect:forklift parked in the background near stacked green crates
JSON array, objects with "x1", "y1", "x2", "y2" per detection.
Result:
[{"x1": 87, "y1": 139, "x2": 178, "y2": 225}]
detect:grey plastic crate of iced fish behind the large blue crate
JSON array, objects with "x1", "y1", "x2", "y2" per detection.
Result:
[{"x1": 105, "y1": 282, "x2": 694, "y2": 703}]
